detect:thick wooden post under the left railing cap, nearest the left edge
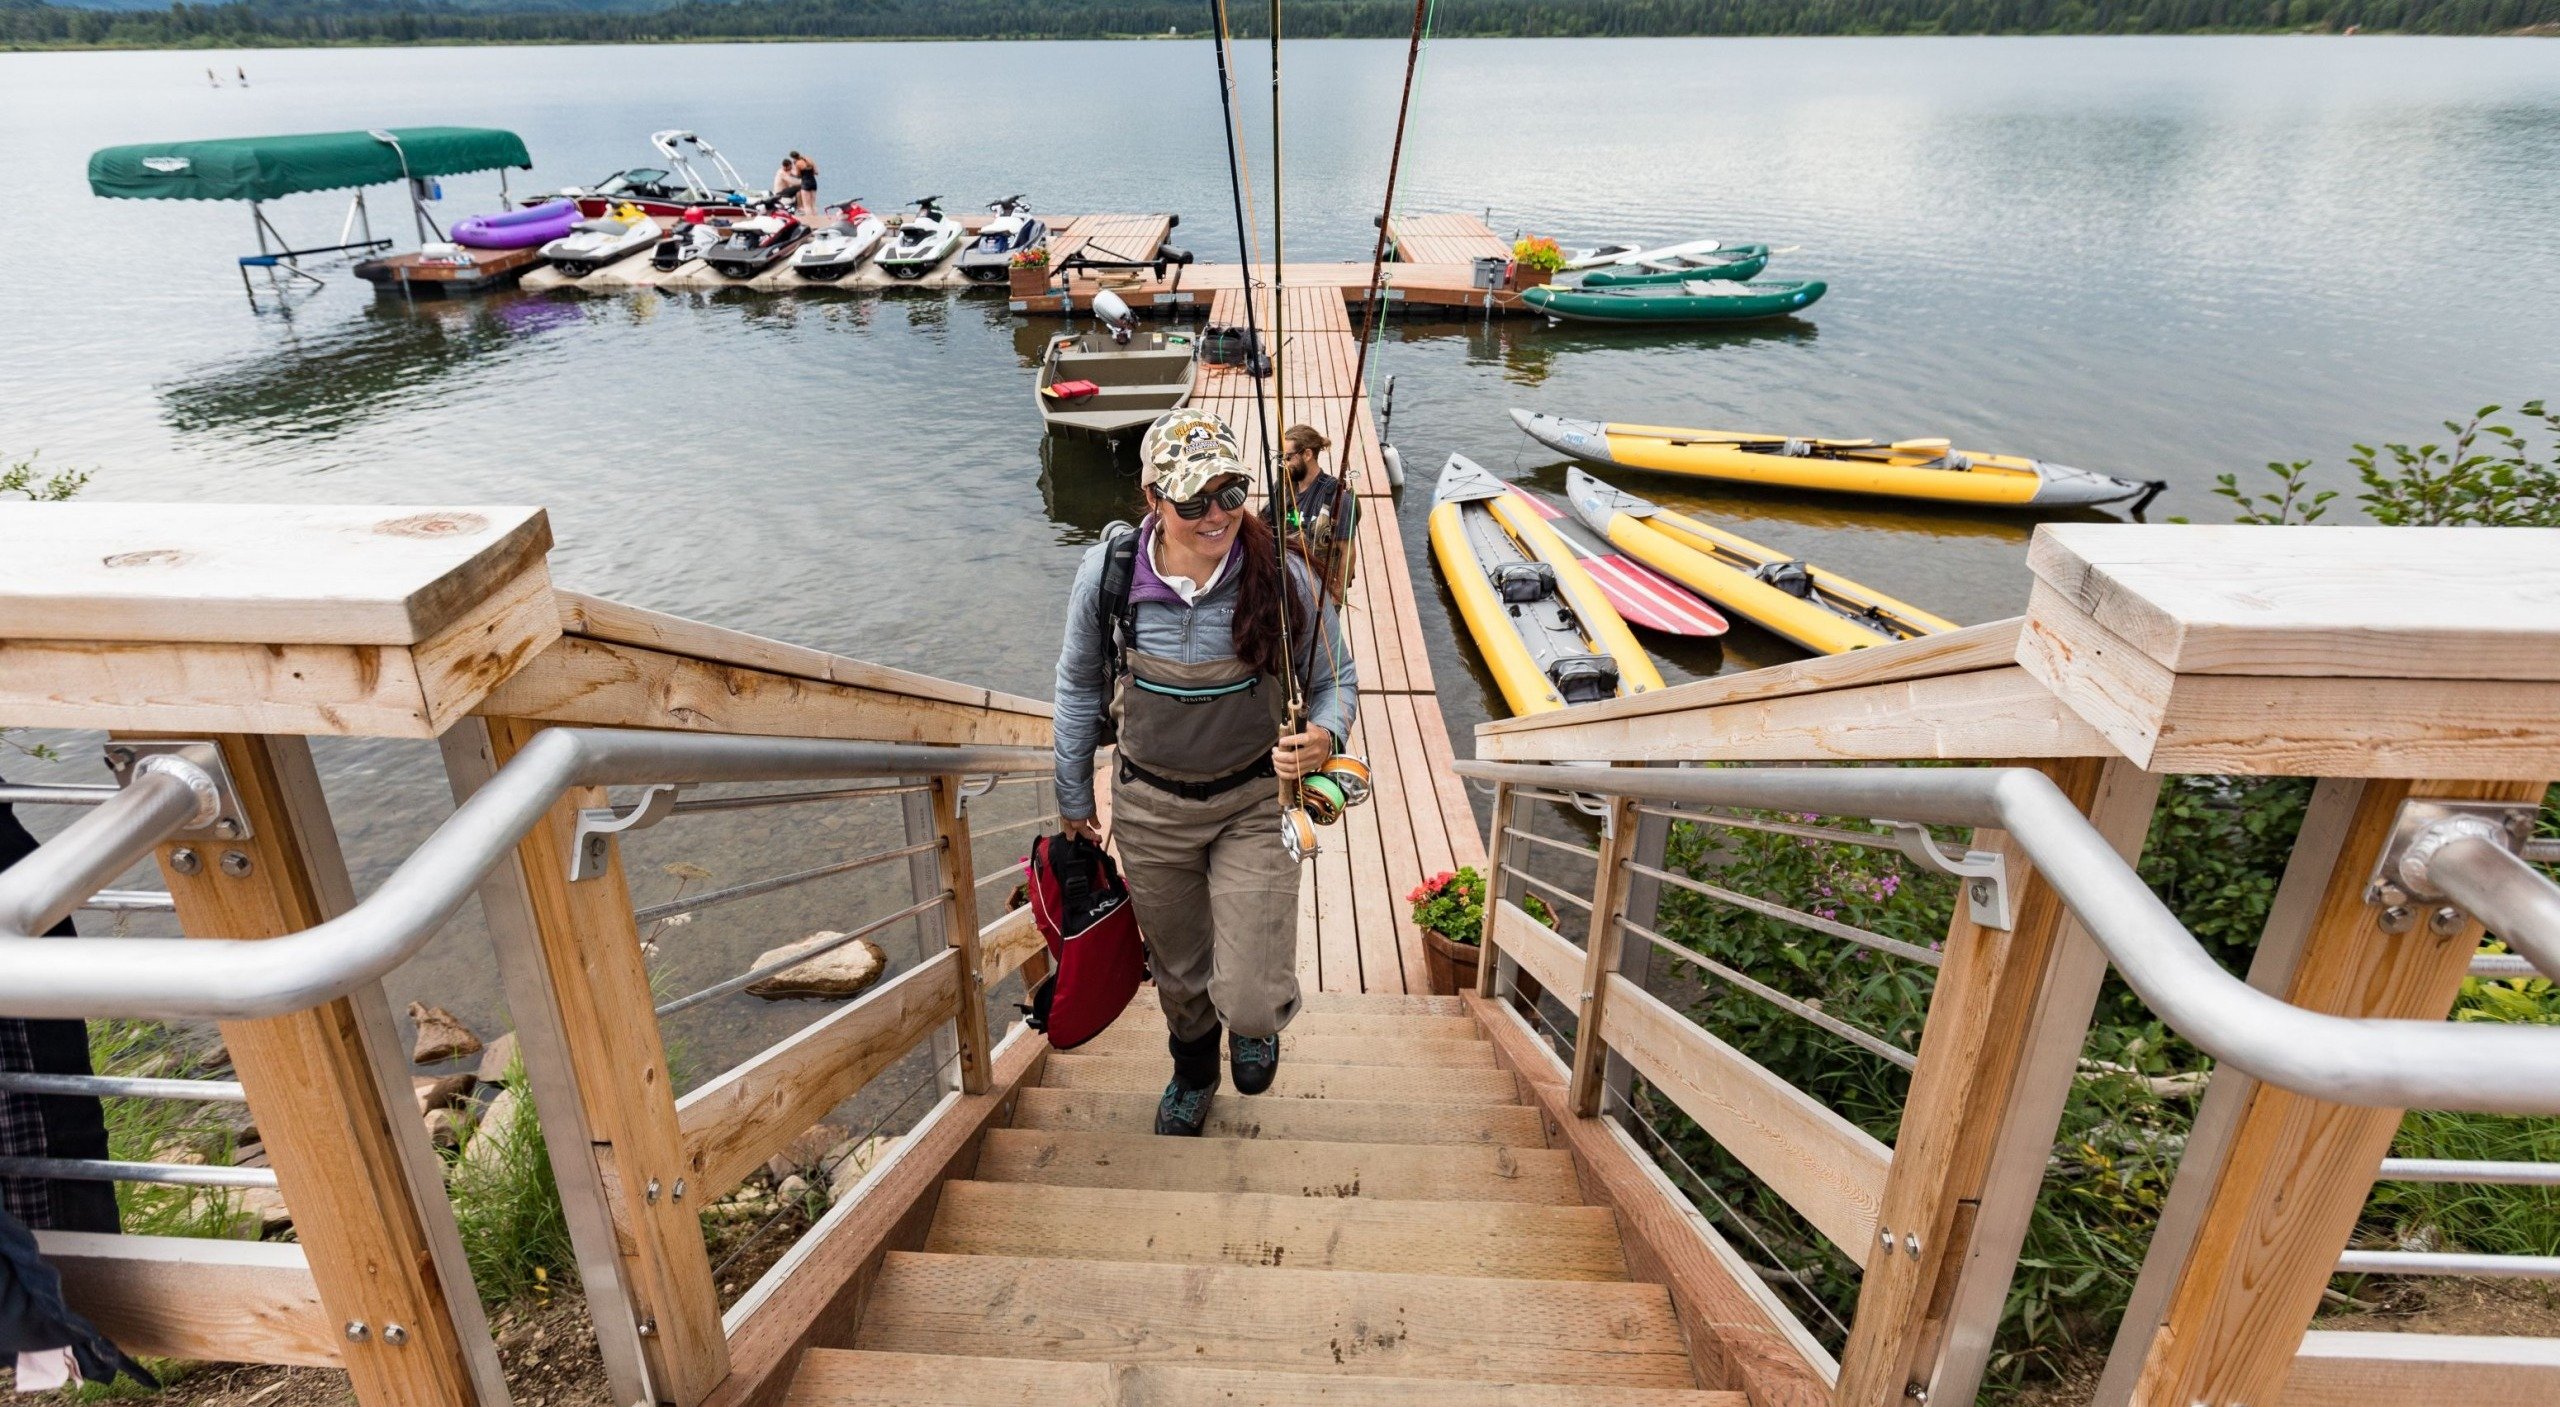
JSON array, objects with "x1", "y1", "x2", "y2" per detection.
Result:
[{"x1": 135, "y1": 734, "x2": 507, "y2": 1407}]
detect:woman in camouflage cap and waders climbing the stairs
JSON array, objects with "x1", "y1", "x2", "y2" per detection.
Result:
[{"x1": 1057, "y1": 409, "x2": 1357, "y2": 1136}]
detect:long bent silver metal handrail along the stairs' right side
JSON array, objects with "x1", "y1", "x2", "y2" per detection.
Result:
[{"x1": 1457, "y1": 762, "x2": 2560, "y2": 1113}]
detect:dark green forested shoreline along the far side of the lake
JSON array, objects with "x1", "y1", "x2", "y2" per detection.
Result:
[{"x1": 0, "y1": 0, "x2": 2560, "y2": 49}]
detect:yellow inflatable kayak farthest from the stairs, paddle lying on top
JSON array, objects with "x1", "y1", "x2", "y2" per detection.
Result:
[{"x1": 1510, "y1": 409, "x2": 2166, "y2": 512}]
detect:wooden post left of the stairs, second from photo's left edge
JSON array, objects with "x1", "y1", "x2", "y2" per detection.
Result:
[{"x1": 489, "y1": 719, "x2": 730, "y2": 1407}]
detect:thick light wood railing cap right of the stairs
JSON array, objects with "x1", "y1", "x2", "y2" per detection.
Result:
[{"x1": 2017, "y1": 524, "x2": 2560, "y2": 780}]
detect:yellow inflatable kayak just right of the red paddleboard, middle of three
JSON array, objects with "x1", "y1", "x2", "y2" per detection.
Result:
[{"x1": 1556, "y1": 468, "x2": 1956, "y2": 655}]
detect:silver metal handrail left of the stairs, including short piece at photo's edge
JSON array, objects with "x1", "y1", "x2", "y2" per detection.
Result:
[{"x1": 0, "y1": 729, "x2": 1055, "y2": 1018}]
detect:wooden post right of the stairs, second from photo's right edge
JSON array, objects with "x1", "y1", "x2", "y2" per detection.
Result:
[{"x1": 1838, "y1": 757, "x2": 2119, "y2": 1407}]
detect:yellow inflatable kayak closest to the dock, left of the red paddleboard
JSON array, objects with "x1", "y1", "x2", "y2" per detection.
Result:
[{"x1": 1431, "y1": 455, "x2": 1661, "y2": 714}]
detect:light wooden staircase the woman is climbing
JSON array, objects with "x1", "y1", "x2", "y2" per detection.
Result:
[{"x1": 788, "y1": 993, "x2": 1743, "y2": 1407}]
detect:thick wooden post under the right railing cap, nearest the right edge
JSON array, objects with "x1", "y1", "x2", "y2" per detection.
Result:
[{"x1": 2132, "y1": 780, "x2": 2545, "y2": 1407}]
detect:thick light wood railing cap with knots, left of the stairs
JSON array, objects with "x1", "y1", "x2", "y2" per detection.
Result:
[{"x1": 0, "y1": 501, "x2": 561, "y2": 737}]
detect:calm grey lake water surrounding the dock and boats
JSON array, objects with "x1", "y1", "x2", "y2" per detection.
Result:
[{"x1": 0, "y1": 38, "x2": 2560, "y2": 1059}]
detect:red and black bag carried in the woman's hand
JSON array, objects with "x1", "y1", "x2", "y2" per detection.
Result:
[{"x1": 1021, "y1": 837, "x2": 1147, "y2": 1051}]
